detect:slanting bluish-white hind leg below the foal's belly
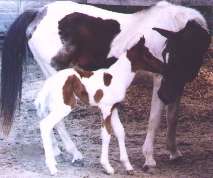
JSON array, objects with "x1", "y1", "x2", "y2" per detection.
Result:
[{"x1": 55, "y1": 121, "x2": 83, "y2": 162}]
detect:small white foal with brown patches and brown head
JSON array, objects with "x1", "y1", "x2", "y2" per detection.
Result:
[{"x1": 35, "y1": 38, "x2": 163, "y2": 174}]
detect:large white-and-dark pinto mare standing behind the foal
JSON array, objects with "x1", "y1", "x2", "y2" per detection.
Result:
[{"x1": 1, "y1": 1, "x2": 209, "y2": 171}]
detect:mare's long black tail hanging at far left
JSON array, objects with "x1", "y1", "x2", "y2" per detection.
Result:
[{"x1": 0, "y1": 10, "x2": 37, "y2": 135}]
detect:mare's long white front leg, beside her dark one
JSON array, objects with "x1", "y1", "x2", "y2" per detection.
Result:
[{"x1": 143, "y1": 76, "x2": 164, "y2": 168}]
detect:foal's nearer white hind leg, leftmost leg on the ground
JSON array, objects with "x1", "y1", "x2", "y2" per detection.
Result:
[{"x1": 40, "y1": 108, "x2": 70, "y2": 174}]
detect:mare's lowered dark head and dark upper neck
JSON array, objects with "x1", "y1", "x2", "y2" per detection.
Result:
[{"x1": 153, "y1": 20, "x2": 210, "y2": 104}]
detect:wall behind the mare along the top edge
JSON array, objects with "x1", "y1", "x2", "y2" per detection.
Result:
[{"x1": 0, "y1": 0, "x2": 213, "y2": 44}]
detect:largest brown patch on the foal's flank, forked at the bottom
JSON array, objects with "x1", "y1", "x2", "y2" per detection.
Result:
[{"x1": 63, "y1": 75, "x2": 89, "y2": 107}]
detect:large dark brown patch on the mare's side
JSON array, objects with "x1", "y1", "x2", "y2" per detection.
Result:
[{"x1": 51, "y1": 12, "x2": 120, "y2": 70}]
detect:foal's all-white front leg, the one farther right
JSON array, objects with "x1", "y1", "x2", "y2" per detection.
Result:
[{"x1": 111, "y1": 109, "x2": 133, "y2": 174}]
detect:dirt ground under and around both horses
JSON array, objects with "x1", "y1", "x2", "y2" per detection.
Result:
[{"x1": 0, "y1": 48, "x2": 213, "y2": 178}]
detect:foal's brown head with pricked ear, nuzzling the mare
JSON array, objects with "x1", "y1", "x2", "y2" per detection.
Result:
[{"x1": 127, "y1": 37, "x2": 165, "y2": 74}]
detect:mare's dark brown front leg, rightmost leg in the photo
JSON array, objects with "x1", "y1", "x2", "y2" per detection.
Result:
[{"x1": 167, "y1": 97, "x2": 182, "y2": 160}]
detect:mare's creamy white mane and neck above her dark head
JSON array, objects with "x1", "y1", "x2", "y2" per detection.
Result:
[{"x1": 108, "y1": 1, "x2": 207, "y2": 62}]
